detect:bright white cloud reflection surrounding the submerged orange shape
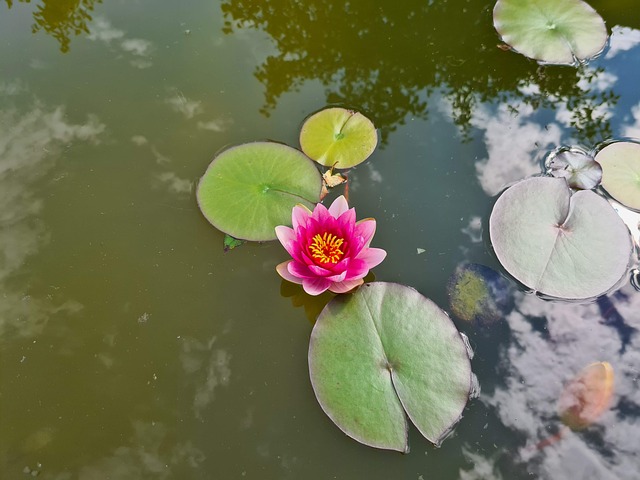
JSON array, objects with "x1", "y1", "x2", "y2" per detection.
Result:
[{"x1": 465, "y1": 285, "x2": 640, "y2": 480}]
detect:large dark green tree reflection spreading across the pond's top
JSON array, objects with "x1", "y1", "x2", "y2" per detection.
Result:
[{"x1": 222, "y1": 0, "x2": 618, "y2": 145}]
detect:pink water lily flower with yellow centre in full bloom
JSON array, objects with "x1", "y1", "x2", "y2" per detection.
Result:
[{"x1": 276, "y1": 196, "x2": 387, "y2": 295}]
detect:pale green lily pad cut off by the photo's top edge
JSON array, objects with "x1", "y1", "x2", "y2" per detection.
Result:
[{"x1": 493, "y1": 0, "x2": 607, "y2": 65}]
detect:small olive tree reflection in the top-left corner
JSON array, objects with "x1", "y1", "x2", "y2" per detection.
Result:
[{"x1": 5, "y1": 0, "x2": 102, "y2": 52}]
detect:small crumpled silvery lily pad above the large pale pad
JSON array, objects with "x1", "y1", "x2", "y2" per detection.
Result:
[{"x1": 546, "y1": 148, "x2": 602, "y2": 190}]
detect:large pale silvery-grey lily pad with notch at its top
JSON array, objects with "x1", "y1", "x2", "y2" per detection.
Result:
[{"x1": 489, "y1": 177, "x2": 632, "y2": 299}]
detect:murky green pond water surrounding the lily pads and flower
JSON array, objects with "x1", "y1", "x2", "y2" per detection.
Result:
[{"x1": 0, "y1": 0, "x2": 640, "y2": 480}]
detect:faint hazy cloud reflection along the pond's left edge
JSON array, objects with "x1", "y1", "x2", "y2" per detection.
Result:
[{"x1": 0, "y1": 93, "x2": 105, "y2": 336}]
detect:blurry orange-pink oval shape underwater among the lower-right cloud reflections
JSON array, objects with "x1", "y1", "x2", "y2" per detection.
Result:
[{"x1": 558, "y1": 362, "x2": 614, "y2": 430}]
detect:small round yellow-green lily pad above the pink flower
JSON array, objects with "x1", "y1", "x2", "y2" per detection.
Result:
[{"x1": 300, "y1": 107, "x2": 378, "y2": 168}]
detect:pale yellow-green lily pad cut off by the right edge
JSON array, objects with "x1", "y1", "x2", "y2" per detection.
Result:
[{"x1": 596, "y1": 142, "x2": 640, "y2": 210}]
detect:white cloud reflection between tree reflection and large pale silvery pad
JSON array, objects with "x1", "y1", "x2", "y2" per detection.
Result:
[{"x1": 471, "y1": 103, "x2": 561, "y2": 196}]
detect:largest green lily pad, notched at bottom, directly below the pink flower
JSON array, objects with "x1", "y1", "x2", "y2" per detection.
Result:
[{"x1": 309, "y1": 282, "x2": 472, "y2": 452}]
